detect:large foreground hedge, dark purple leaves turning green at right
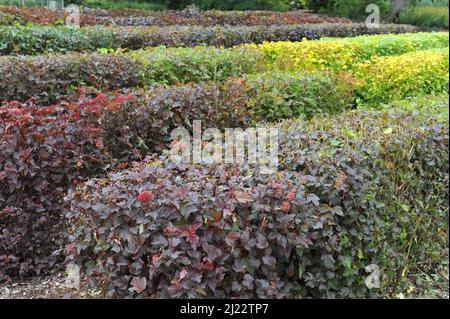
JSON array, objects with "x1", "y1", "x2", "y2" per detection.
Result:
[{"x1": 66, "y1": 107, "x2": 449, "y2": 298}]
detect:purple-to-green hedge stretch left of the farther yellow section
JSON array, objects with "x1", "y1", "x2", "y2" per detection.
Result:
[{"x1": 0, "y1": 47, "x2": 266, "y2": 103}]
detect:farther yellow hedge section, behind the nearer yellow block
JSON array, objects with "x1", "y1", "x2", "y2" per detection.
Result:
[{"x1": 249, "y1": 32, "x2": 449, "y2": 70}]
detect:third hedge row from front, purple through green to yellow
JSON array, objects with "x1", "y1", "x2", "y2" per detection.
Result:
[{"x1": 0, "y1": 33, "x2": 448, "y2": 102}]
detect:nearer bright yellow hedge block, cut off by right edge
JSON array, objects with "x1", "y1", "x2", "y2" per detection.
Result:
[{"x1": 356, "y1": 48, "x2": 449, "y2": 105}]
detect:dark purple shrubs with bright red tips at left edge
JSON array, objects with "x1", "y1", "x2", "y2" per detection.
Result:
[{"x1": 0, "y1": 95, "x2": 125, "y2": 281}]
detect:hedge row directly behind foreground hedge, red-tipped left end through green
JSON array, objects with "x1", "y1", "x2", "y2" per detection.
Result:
[{"x1": 0, "y1": 74, "x2": 351, "y2": 280}]
